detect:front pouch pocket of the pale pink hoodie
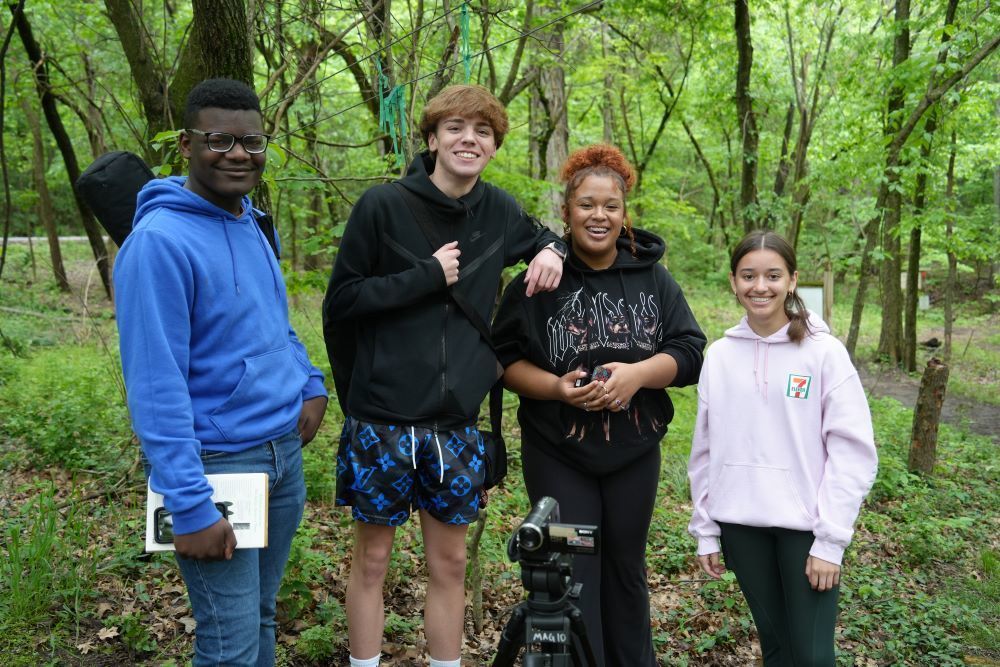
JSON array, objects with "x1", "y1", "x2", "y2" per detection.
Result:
[{"x1": 709, "y1": 463, "x2": 814, "y2": 530}]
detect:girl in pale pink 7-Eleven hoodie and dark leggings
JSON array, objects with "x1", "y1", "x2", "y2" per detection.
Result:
[{"x1": 688, "y1": 231, "x2": 877, "y2": 667}]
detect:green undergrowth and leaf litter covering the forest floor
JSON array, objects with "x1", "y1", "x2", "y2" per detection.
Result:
[{"x1": 0, "y1": 247, "x2": 1000, "y2": 666}]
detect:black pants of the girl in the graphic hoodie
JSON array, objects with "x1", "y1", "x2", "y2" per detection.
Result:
[{"x1": 521, "y1": 444, "x2": 660, "y2": 667}]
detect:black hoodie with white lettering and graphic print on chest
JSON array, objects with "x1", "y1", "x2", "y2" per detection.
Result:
[{"x1": 493, "y1": 229, "x2": 705, "y2": 475}]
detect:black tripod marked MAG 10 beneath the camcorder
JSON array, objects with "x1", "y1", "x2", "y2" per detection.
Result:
[{"x1": 493, "y1": 554, "x2": 597, "y2": 667}]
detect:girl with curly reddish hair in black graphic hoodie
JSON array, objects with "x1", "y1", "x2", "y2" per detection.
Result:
[{"x1": 493, "y1": 145, "x2": 705, "y2": 667}]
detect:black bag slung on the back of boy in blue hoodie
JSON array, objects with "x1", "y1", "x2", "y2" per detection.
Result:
[{"x1": 76, "y1": 151, "x2": 281, "y2": 259}]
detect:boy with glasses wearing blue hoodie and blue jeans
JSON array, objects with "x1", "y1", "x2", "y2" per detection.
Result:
[{"x1": 114, "y1": 79, "x2": 327, "y2": 666}]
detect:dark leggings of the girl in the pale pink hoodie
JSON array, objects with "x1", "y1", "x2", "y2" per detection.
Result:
[{"x1": 719, "y1": 523, "x2": 840, "y2": 667}]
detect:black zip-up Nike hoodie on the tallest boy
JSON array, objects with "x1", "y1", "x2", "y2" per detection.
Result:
[{"x1": 323, "y1": 152, "x2": 558, "y2": 429}]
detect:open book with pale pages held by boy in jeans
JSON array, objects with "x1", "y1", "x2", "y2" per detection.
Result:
[{"x1": 146, "y1": 472, "x2": 268, "y2": 551}]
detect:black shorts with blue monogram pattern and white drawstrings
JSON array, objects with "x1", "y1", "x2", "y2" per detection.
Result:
[{"x1": 337, "y1": 417, "x2": 486, "y2": 526}]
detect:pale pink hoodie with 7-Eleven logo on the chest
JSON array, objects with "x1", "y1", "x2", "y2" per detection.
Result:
[{"x1": 688, "y1": 315, "x2": 878, "y2": 564}]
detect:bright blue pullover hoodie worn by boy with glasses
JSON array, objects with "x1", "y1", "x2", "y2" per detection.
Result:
[{"x1": 114, "y1": 178, "x2": 326, "y2": 535}]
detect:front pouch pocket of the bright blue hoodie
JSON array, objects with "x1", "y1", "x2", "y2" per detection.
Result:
[{"x1": 210, "y1": 345, "x2": 309, "y2": 442}]
